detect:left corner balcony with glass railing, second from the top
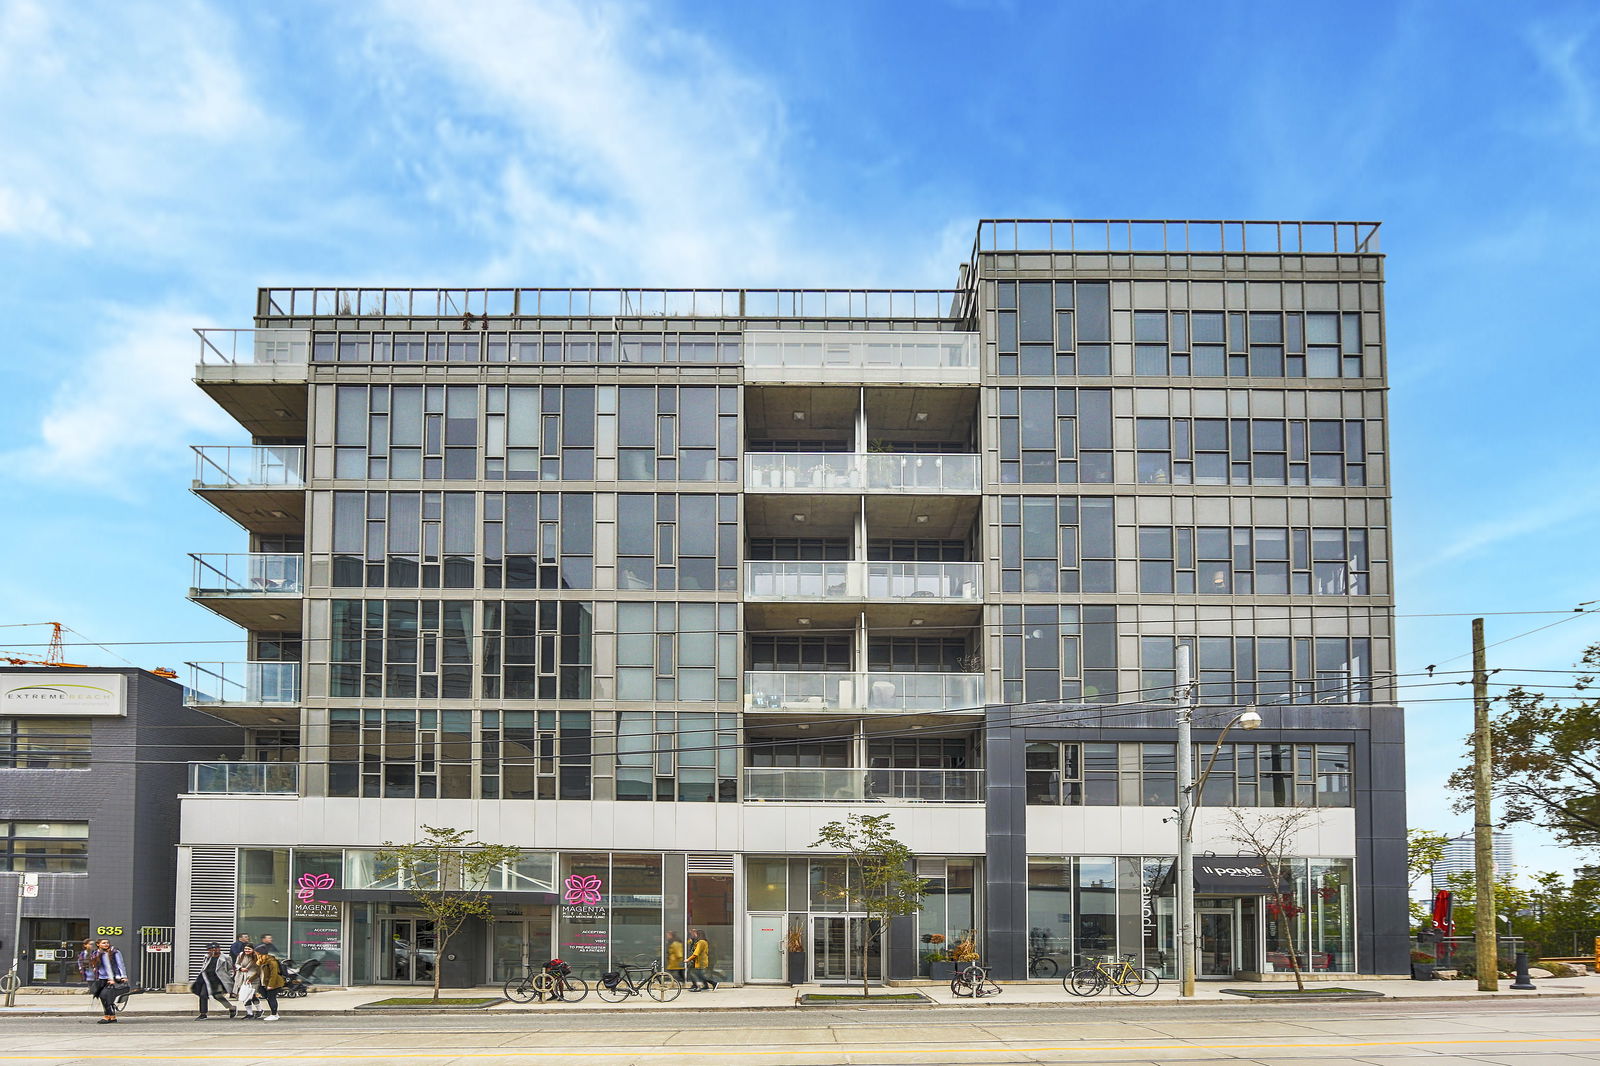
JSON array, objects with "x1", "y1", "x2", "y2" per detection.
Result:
[{"x1": 194, "y1": 445, "x2": 306, "y2": 533}]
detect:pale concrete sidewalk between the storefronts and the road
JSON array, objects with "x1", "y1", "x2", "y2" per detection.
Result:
[{"x1": 0, "y1": 976, "x2": 1600, "y2": 1015}]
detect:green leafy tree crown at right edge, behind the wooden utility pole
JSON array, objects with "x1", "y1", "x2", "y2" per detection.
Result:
[{"x1": 1450, "y1": 643, "x2": 1600, "y2": 848}]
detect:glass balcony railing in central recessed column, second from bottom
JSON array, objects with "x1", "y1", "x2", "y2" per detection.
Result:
[{"x1": 744, "y1": 671, "x2": 984, "y2": 712}]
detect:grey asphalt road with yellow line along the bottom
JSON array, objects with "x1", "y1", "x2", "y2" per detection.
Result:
[{"x1": 0, "y1": 999, "x2": 1600, "y2": 1066}]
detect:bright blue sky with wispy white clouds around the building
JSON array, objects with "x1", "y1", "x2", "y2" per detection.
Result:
[{"x1": 0, "y1": 0, "x2": 1600, "y2": 871}]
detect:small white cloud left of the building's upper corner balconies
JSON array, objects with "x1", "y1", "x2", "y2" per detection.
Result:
[{"x1": 0, "y1": 307, "x2": 238, "y2": 498}]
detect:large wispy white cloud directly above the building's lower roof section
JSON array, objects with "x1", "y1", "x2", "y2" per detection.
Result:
[{"x1": 373, "y1": 0, "x2": 851, "y2": 285}]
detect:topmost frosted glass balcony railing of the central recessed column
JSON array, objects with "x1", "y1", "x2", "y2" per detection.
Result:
[{"x1": 744, "y1": 330, "x2": 978, "y2": 386}]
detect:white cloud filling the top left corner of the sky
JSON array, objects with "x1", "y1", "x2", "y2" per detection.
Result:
[{"x1": 0, "y1": 0, "x2": 274, "y2": 249}]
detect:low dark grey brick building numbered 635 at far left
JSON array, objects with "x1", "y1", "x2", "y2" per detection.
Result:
[{"x1": 0, "y1": 667, "x2": 245, "y2": 984}]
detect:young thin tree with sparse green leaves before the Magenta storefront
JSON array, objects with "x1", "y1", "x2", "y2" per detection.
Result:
[{"x1": 378, "y1": 826, "x2": 522, "y2": 1000}]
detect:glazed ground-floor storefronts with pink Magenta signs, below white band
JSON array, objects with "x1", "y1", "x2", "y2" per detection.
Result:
[{"x1": 178, "y1": 847, "x2": 1376, "y2": 988}]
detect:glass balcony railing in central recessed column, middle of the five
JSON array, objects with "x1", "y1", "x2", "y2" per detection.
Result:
[{"x1": 744, "y1": 560, "x2": 982, "y2": 603}]
